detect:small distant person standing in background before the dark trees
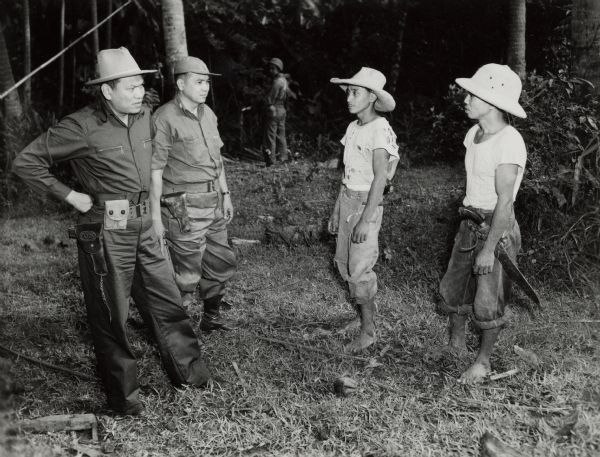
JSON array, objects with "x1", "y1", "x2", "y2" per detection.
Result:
[{"x1": 263, "y1": 57, "x2": 289, "y2": 166}]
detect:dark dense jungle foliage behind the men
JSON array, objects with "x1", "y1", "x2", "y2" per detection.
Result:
[{"x1": 0, "y1": 0, "x2": 600, "y2": 288}]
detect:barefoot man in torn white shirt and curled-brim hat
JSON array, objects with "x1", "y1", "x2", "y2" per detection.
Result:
[{"x1": 329, "y1": 67, "x2": 399, "y2": 352}]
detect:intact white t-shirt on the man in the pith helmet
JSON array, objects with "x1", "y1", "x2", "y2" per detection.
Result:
[{"x1": 463, "y1": 124, "x2": 527, "y2": 211}]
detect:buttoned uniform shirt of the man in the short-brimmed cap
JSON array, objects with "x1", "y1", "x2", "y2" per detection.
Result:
[{"x1": 152, "y1": 97, "x2": 223, "y2": 184}]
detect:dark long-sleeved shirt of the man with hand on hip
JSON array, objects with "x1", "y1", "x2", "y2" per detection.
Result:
[{"x1": 13, "y1": 104, "x2": 152, "y2": 200}]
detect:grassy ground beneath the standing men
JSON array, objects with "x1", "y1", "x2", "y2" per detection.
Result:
[{"x1": 0, "y1": 163, "x2": 600, "y2": 456}]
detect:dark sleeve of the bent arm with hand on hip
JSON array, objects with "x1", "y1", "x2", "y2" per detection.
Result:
[{"x1": 13, "y1": 117, "x2": 89, "y2": 200}]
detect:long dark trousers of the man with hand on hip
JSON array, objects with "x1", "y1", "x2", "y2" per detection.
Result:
[{"x1": 78, "y1": 209, "x2": 210, "y2": 412}]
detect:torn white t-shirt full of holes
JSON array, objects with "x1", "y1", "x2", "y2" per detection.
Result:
[{"x1": 341, "y1": 117, "x2": 400, "y2": 191}]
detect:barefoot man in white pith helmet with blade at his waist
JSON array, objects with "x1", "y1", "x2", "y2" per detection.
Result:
[{"x1": 440, "y1": 64, "x2": 527, "y2": 383}]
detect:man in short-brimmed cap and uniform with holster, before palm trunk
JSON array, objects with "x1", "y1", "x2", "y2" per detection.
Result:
[{"x1": 150, "y1": 57, "x2": 236, "y2": 332}]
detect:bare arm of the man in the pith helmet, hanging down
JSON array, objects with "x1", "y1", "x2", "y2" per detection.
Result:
[{"x1": 473, "y1": 164, "x2": 519, "y2": 274}]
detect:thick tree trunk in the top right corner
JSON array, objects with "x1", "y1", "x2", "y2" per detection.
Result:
[{"x1": 571, "y1": 0, "x2": 600, "y2": 92}]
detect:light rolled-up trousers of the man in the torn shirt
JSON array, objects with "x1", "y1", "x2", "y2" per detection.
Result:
[{"x1": 335, "y1": 188, "x2": 383, "y2": 305}]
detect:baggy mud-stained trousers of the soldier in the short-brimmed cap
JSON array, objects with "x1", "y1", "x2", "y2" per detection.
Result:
[{"x1": 162, "y1": 206, "x2": 237, "y2": 300}]
